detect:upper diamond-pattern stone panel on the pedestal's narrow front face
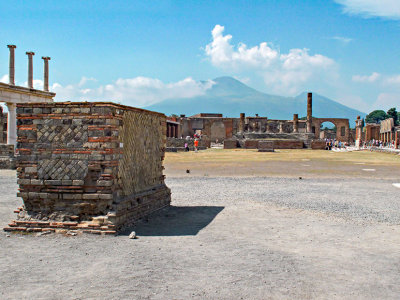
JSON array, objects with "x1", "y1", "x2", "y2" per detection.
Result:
[{"x1": 37, "y1": 125, "x2": 88, "y2": 147}]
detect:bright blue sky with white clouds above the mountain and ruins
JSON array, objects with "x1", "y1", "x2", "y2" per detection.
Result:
[{"x1": 0, "y1": 0, "x2": 400, "y2": 112}]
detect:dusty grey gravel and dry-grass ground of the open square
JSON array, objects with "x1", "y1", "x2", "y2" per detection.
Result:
[{"x1": 0, "y1": 151, "x2": 400, "y2": 299}]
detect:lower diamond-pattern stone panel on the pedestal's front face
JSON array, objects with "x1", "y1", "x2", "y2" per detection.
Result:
[{"x1": 38, "y1": 159, "x2": 88, "y2": 180}]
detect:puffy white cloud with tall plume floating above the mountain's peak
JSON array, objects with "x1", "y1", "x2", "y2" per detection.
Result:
[{"x1": 205, "y1": 25, "x2": 336, "y2": 95}]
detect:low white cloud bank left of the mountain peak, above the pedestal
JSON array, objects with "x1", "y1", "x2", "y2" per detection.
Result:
[{"x1": 51, "y1": 77, "x2": 214, "y2": 107}]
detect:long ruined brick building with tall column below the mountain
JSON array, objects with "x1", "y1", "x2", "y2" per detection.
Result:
[{"x1": 167, "y1": 93, "x2": 351, "y2": 148}]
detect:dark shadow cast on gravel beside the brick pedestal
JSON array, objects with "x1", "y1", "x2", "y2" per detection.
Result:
[{"x1": 122, "y1": 206, "x2": 224, "y2": 236}]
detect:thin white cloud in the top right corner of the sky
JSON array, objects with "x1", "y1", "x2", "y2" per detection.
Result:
[{"x1": 335, "y1": 0, "x2": 400, "y2": 19}]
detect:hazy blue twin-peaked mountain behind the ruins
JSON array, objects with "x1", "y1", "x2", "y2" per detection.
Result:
[{"x1": 146, "y1": 77, "x2": 366, "y2": 122}]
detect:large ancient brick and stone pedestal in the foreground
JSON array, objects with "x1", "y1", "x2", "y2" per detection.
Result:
[{"x1": 4, "y1": 102, "x2": 171, "y2": 234}]
